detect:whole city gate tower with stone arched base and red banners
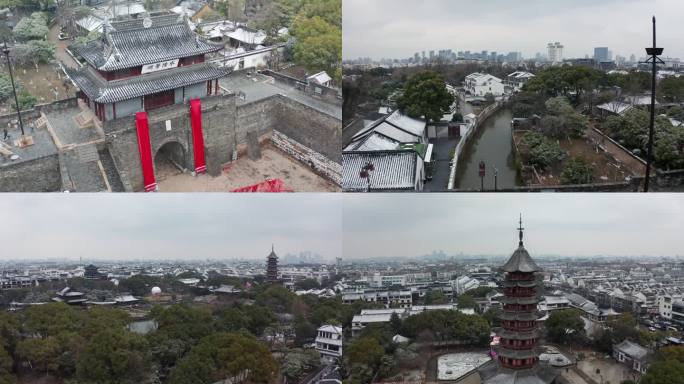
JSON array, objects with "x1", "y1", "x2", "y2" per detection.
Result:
[{"x1": 66, "y1": 13, "x2": 235, "y2": 190}]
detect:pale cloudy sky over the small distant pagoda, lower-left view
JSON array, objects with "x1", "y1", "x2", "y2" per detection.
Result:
[{"x1": 0, "y1": 193, "x2": 342, "y2": 260}]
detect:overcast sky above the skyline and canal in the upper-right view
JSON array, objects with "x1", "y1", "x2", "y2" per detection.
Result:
[{"x1": 342, "y1": 0, "x2": 684, "y2": 59}]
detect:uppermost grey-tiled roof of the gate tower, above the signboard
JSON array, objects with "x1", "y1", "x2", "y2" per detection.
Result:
[{"x1": 69, "y1": 14, "x2": 223, "y2": 71}]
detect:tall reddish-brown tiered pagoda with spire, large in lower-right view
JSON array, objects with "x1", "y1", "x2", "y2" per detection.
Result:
[{"x1": 480, "y1": 217, "x2": 557, "y2": 384}]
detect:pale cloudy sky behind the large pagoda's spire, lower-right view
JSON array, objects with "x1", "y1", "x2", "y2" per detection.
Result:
[{"x1": 343, "y1": 193, "x2": 684, "y2": 259}]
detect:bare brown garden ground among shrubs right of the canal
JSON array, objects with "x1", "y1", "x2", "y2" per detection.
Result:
[{"x1": 514, "y1": 131, "x2": 636, "y2": 186}]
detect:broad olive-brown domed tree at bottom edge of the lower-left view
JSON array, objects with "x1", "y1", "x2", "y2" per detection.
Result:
[{"x1": 169, "y1": 333, "x2": 277, "y2": 384}]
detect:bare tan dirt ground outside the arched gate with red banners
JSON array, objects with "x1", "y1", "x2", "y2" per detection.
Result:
[{"x1": 154, "y1": 145, "x2": 340, "y2": 192}]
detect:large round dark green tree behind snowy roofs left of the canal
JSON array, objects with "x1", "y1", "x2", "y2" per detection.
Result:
[{"x1": 397, "y1": 71, "x2": 454, "y2": 122}]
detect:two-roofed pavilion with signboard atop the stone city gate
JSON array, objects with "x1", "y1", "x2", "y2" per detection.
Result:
[{"x1": 67, "y1": 14, "x2": 230, "y2": 121}]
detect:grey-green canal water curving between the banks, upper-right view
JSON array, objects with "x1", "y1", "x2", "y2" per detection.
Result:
[{"x1": 455, "y1": 106, "x2": 522, "y2": 191}]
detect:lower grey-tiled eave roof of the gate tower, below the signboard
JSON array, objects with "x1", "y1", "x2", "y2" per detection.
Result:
[{"x1": 66, "y1": 63, "x2": 232, "y2": 103}]
